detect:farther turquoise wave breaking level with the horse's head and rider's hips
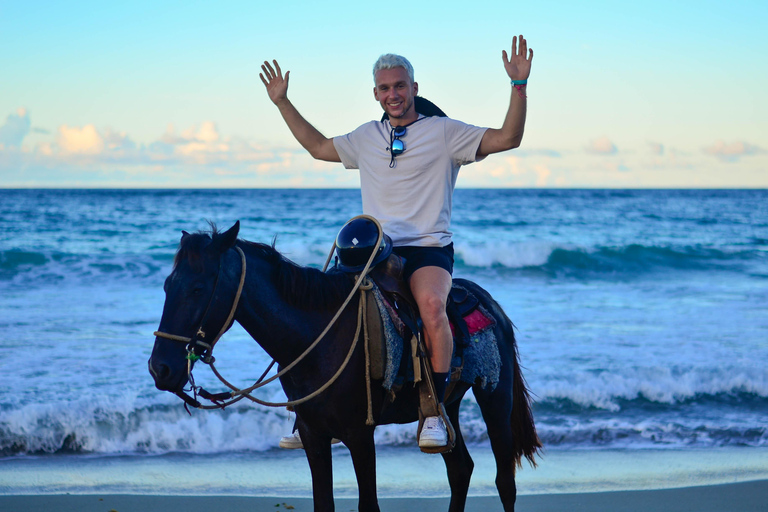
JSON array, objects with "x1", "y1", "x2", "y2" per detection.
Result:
[{"x1": 0, "y1": 242, "x2": 768, "y2": 285}]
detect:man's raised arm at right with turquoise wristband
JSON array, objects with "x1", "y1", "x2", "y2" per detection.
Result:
[{"x1": 477, "y1": 35, "x2": 533, "y2": 158}]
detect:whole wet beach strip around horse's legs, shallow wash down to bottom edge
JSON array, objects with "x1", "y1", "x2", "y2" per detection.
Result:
[{"x1": 0, "y1": 446, "x2": 768, "y2": 512}]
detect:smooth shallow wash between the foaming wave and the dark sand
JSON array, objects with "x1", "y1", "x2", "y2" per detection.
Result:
[{"x1": 0, "y1": 445, "x2": 768, "y2": 498}]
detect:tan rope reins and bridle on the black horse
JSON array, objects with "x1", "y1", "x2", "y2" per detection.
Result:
[{"x1": 154, "y1": 215, "x2": 384, "y2": 414}]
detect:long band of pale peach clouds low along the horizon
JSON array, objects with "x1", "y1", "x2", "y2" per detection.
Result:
[{"x1": 7, "y1": 109, "x2": 768, "y2": 188}]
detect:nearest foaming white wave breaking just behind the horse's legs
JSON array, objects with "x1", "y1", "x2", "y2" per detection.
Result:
[{"x1": 0, "y1": 369, "x2": 768, "y2": 456}]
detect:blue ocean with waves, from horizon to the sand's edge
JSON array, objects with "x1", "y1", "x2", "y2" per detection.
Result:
[{"x1": 0, "y1": 189, "x2": 768, "y2": 496}]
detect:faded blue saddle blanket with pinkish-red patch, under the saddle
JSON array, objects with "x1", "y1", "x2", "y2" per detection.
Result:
[{"x1": 372, "y1": 285, "x2": 501, "y2": 390}]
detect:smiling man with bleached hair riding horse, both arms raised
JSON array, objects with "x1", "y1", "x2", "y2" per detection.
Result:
[{"x1": 259, "y1": 35, "x2": 533, "y2": 448}]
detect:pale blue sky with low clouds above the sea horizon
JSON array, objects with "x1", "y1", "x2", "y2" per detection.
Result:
[{"x1": 0, "y1": 0, "x2": 768, "y2": 188}]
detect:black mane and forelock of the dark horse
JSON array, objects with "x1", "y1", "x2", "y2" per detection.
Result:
[{"x1": 173, "y1": 222, "x2": 353, "y2": 310}]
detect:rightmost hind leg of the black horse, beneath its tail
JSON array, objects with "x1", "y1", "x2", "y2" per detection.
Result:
[{"x1": 473, "y1": 376, "x2": 517, "y2": 512}]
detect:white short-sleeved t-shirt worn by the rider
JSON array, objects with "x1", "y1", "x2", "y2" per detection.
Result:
[{"x1": 333, "y1": 116, "x2": 487, "y2": 247}]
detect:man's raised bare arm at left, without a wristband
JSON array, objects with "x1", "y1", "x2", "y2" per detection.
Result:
[{"x1": 259, "y1": 60, "x2": 341, "y2": 162}]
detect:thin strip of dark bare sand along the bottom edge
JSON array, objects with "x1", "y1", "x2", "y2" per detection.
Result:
[{"x1": 0, "y1": 480, "x2": 768, "y2": 512}]
